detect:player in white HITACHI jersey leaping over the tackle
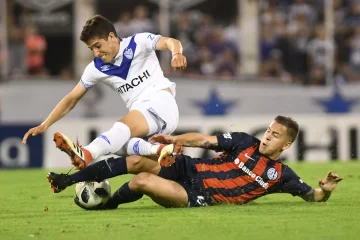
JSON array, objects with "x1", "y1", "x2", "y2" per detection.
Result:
[{"x1": 23, "y1": 15, "x2": 187, "y2": 170}]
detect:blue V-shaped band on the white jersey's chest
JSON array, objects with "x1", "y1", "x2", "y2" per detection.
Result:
[{"x1": 94, "y1": 35, "x2": 137, "y2": 80}]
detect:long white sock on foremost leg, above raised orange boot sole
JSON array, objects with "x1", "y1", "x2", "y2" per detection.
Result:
[{"x1": 84, "y1": 122, "x2": 130, "y2": 159}]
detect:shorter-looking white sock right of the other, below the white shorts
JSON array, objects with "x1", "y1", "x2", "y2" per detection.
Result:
[{"x1": 126, "y1": 138, "x2": 160, "y2": 156}]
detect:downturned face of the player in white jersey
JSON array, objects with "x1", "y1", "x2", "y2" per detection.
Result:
[{"x1": 86, "y1": 32, "x2": 120, "y2": 63}]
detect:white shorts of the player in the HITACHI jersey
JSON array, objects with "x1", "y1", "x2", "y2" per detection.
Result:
[{"x1": 130, "y1": 90, "x2": 179, "y2": 136}]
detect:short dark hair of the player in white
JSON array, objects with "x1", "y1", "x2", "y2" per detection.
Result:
[{"x1": 80, "y1": 14, "x2": 117, "y2": 43}]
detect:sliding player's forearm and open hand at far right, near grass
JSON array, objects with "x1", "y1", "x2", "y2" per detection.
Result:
[{"x1": 302, "y1": 172, "x2": 344, "y2": 202}]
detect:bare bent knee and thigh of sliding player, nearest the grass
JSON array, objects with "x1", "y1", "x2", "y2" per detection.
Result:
[{"x1": 129, "y1": 173, "x2": 188, "y2": 207}]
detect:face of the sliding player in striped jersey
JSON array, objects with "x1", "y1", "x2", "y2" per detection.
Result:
[{"x1": 259, "y1": 121, "x2": 291, "y2": 160}]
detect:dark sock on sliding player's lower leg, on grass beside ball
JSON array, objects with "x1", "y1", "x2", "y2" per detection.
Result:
[{"x1": 106, "y1": 182, "x2": 144, "y2": 208}]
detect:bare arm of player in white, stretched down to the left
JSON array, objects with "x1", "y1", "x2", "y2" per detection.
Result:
[{"x1": 22, "y1": 82, "x2": 86, "y2": 144}]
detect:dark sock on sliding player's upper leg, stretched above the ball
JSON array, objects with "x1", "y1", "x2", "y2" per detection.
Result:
[{"x1": 67, "y1": 157, "x2": 128, "y2": 186}]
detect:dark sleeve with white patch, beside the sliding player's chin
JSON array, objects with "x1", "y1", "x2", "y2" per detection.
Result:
[{"x1": 217, "y1": 132, "x2": 260, "y2": 152}]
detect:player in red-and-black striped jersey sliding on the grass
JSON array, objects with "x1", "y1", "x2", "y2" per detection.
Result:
[{"x1": 49, "y1": 116, "x2": 343, "y2": 208}]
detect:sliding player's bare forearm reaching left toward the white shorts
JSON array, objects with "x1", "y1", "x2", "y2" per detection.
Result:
[{"x1": 149, "y1": 133, "x2": 219, "y2": 150}]
